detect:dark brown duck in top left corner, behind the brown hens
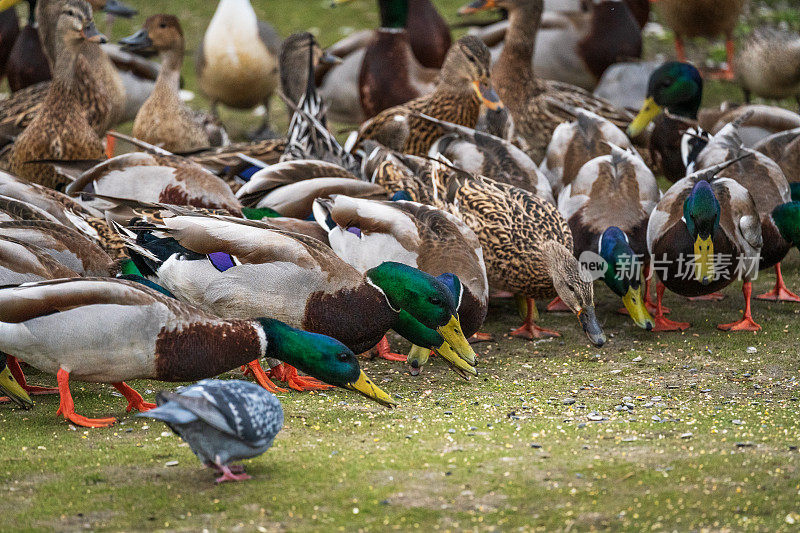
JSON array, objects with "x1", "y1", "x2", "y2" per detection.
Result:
[{"x1": 6, "y1": 0, "x2": 52, "y2": 92}]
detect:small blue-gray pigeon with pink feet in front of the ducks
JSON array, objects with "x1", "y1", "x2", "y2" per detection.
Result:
[{"x1": 139, "y1": 379, "x2": 283, "y2": 483}]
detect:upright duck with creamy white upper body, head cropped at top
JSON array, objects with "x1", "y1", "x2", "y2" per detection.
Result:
[{"x1": 195, "y1": 0, "x2": 281, "y2": 137}]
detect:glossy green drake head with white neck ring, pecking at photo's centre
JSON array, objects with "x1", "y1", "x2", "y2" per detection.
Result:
[{"x1": 366, "y1": 261, "x2": 475, "y2": 368}]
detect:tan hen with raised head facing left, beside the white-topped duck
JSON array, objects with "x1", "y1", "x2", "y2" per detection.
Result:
[{"x1": 120, "y1": 15, "x2": 227, "y2": 152}]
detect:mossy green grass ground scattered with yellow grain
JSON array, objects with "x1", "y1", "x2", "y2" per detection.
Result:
[{"x1": 0, "y1": 0, "x2": 800, "y2": 531}]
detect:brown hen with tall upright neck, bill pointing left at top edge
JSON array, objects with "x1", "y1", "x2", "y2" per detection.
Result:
[{"x1": 459, "y1": 0, "x2": 630, "y2": 164}]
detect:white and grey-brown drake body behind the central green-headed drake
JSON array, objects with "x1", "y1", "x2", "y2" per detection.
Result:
[{"x1": 313, "y1": 194, "x2": 489, "y2": 370}]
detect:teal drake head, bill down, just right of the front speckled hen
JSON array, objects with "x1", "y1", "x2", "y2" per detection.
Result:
[{"x1": 598, "y1": 226, "x2": 655, "y2": 331}]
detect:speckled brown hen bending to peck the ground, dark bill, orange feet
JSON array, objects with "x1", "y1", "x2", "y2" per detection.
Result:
[{"x1": 428, "y1": 164, "x2": 606, "y2": 346}]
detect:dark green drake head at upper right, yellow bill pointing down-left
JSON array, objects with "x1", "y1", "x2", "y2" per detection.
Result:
[{"x1": 628, "y1": 61, "x2": 703, "y2": 137}]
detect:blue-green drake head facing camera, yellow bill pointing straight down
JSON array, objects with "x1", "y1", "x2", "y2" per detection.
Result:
[{"x1": 683, "y1": 180, "x2": 720, "y2": 285}]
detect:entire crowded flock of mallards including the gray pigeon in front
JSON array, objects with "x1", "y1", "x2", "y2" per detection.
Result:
[{"x1": 0, "y1": 0, "x2": 800, "y2": 481}]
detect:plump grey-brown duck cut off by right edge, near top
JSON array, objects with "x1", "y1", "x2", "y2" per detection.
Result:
[{"x1": 736, "y1": 28, "x2": 800, "y2": 106}]
